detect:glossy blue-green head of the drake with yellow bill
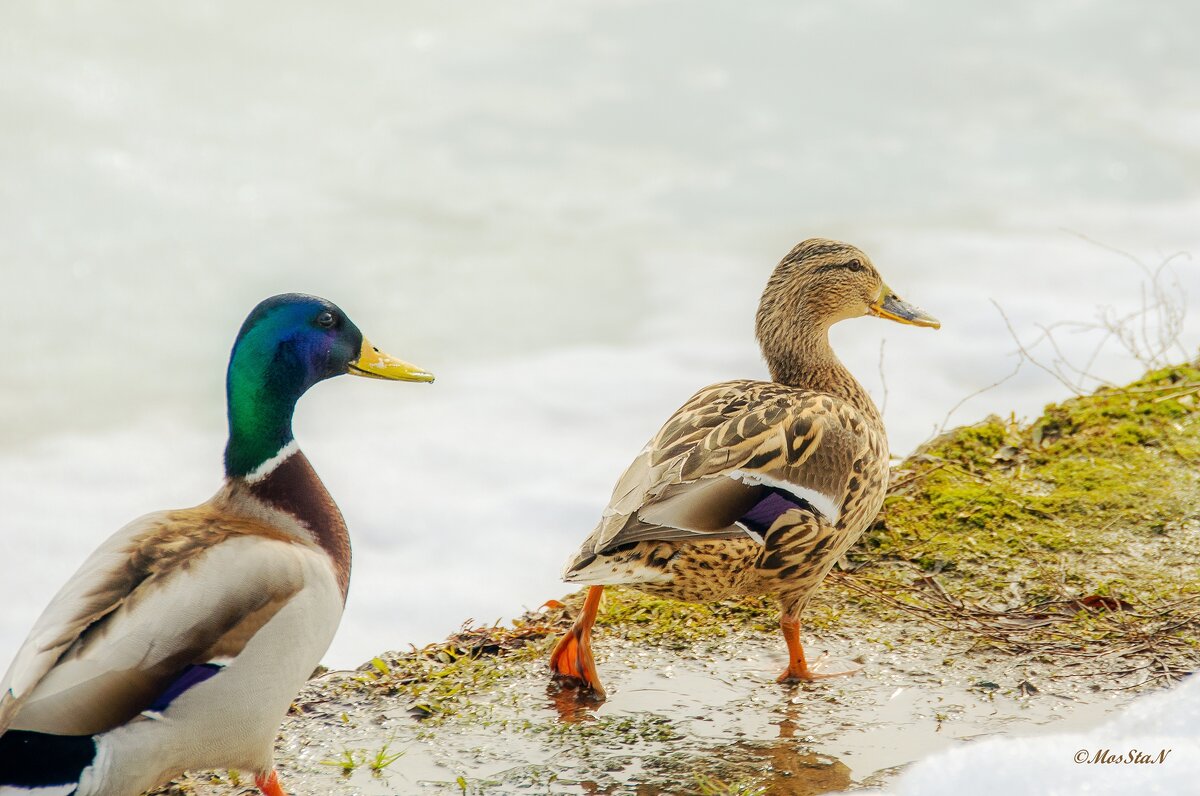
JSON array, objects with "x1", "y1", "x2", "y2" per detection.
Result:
[{"x1": 226, "y1": 293, "x2": 433, "y2": 478}]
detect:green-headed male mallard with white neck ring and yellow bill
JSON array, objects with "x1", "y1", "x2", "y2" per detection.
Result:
[{"x1": 0, "y1": 294, "x2": 433, "y2": 796}]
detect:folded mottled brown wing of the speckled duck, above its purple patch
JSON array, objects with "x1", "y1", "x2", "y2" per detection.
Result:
[{"x1": 584, "y1": 381, "x2": 871, "y2": 552}]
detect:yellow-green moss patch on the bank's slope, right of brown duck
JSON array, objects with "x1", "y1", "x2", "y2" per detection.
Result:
[{"x1": 853, "y1": 366, "x2": 1200, "y2": 612}]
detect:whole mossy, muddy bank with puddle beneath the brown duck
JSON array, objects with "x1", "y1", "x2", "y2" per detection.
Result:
[{"x1": 162, "y1": 366, "x2": 1200, "y2": 795}]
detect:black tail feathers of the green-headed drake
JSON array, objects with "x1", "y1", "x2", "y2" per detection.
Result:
[{"x1": 0, "y1": 730, "x2": 96, "y2": 796}]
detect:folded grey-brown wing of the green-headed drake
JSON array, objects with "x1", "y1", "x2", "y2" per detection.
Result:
[{"x1": 0, "y1": 509, "x2": 312, "y2": 735}]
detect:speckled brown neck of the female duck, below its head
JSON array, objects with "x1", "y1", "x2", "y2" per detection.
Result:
[{"x1": 758, "y1": 318, "x2": 880, "y2": 419}]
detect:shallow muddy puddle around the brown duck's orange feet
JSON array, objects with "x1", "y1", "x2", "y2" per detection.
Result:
[{"x1": 174, "y1": 627, "x2": 1130, "y2": 796}]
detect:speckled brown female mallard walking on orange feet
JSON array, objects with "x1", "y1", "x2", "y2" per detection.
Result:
[{"x1": 551, "y1": 239, "x2": 940, "y2": 696}]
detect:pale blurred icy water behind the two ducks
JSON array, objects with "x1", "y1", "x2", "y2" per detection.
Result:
[{"x1": 0, "y1": 0, "x2": 1200, "y2": 665}]
